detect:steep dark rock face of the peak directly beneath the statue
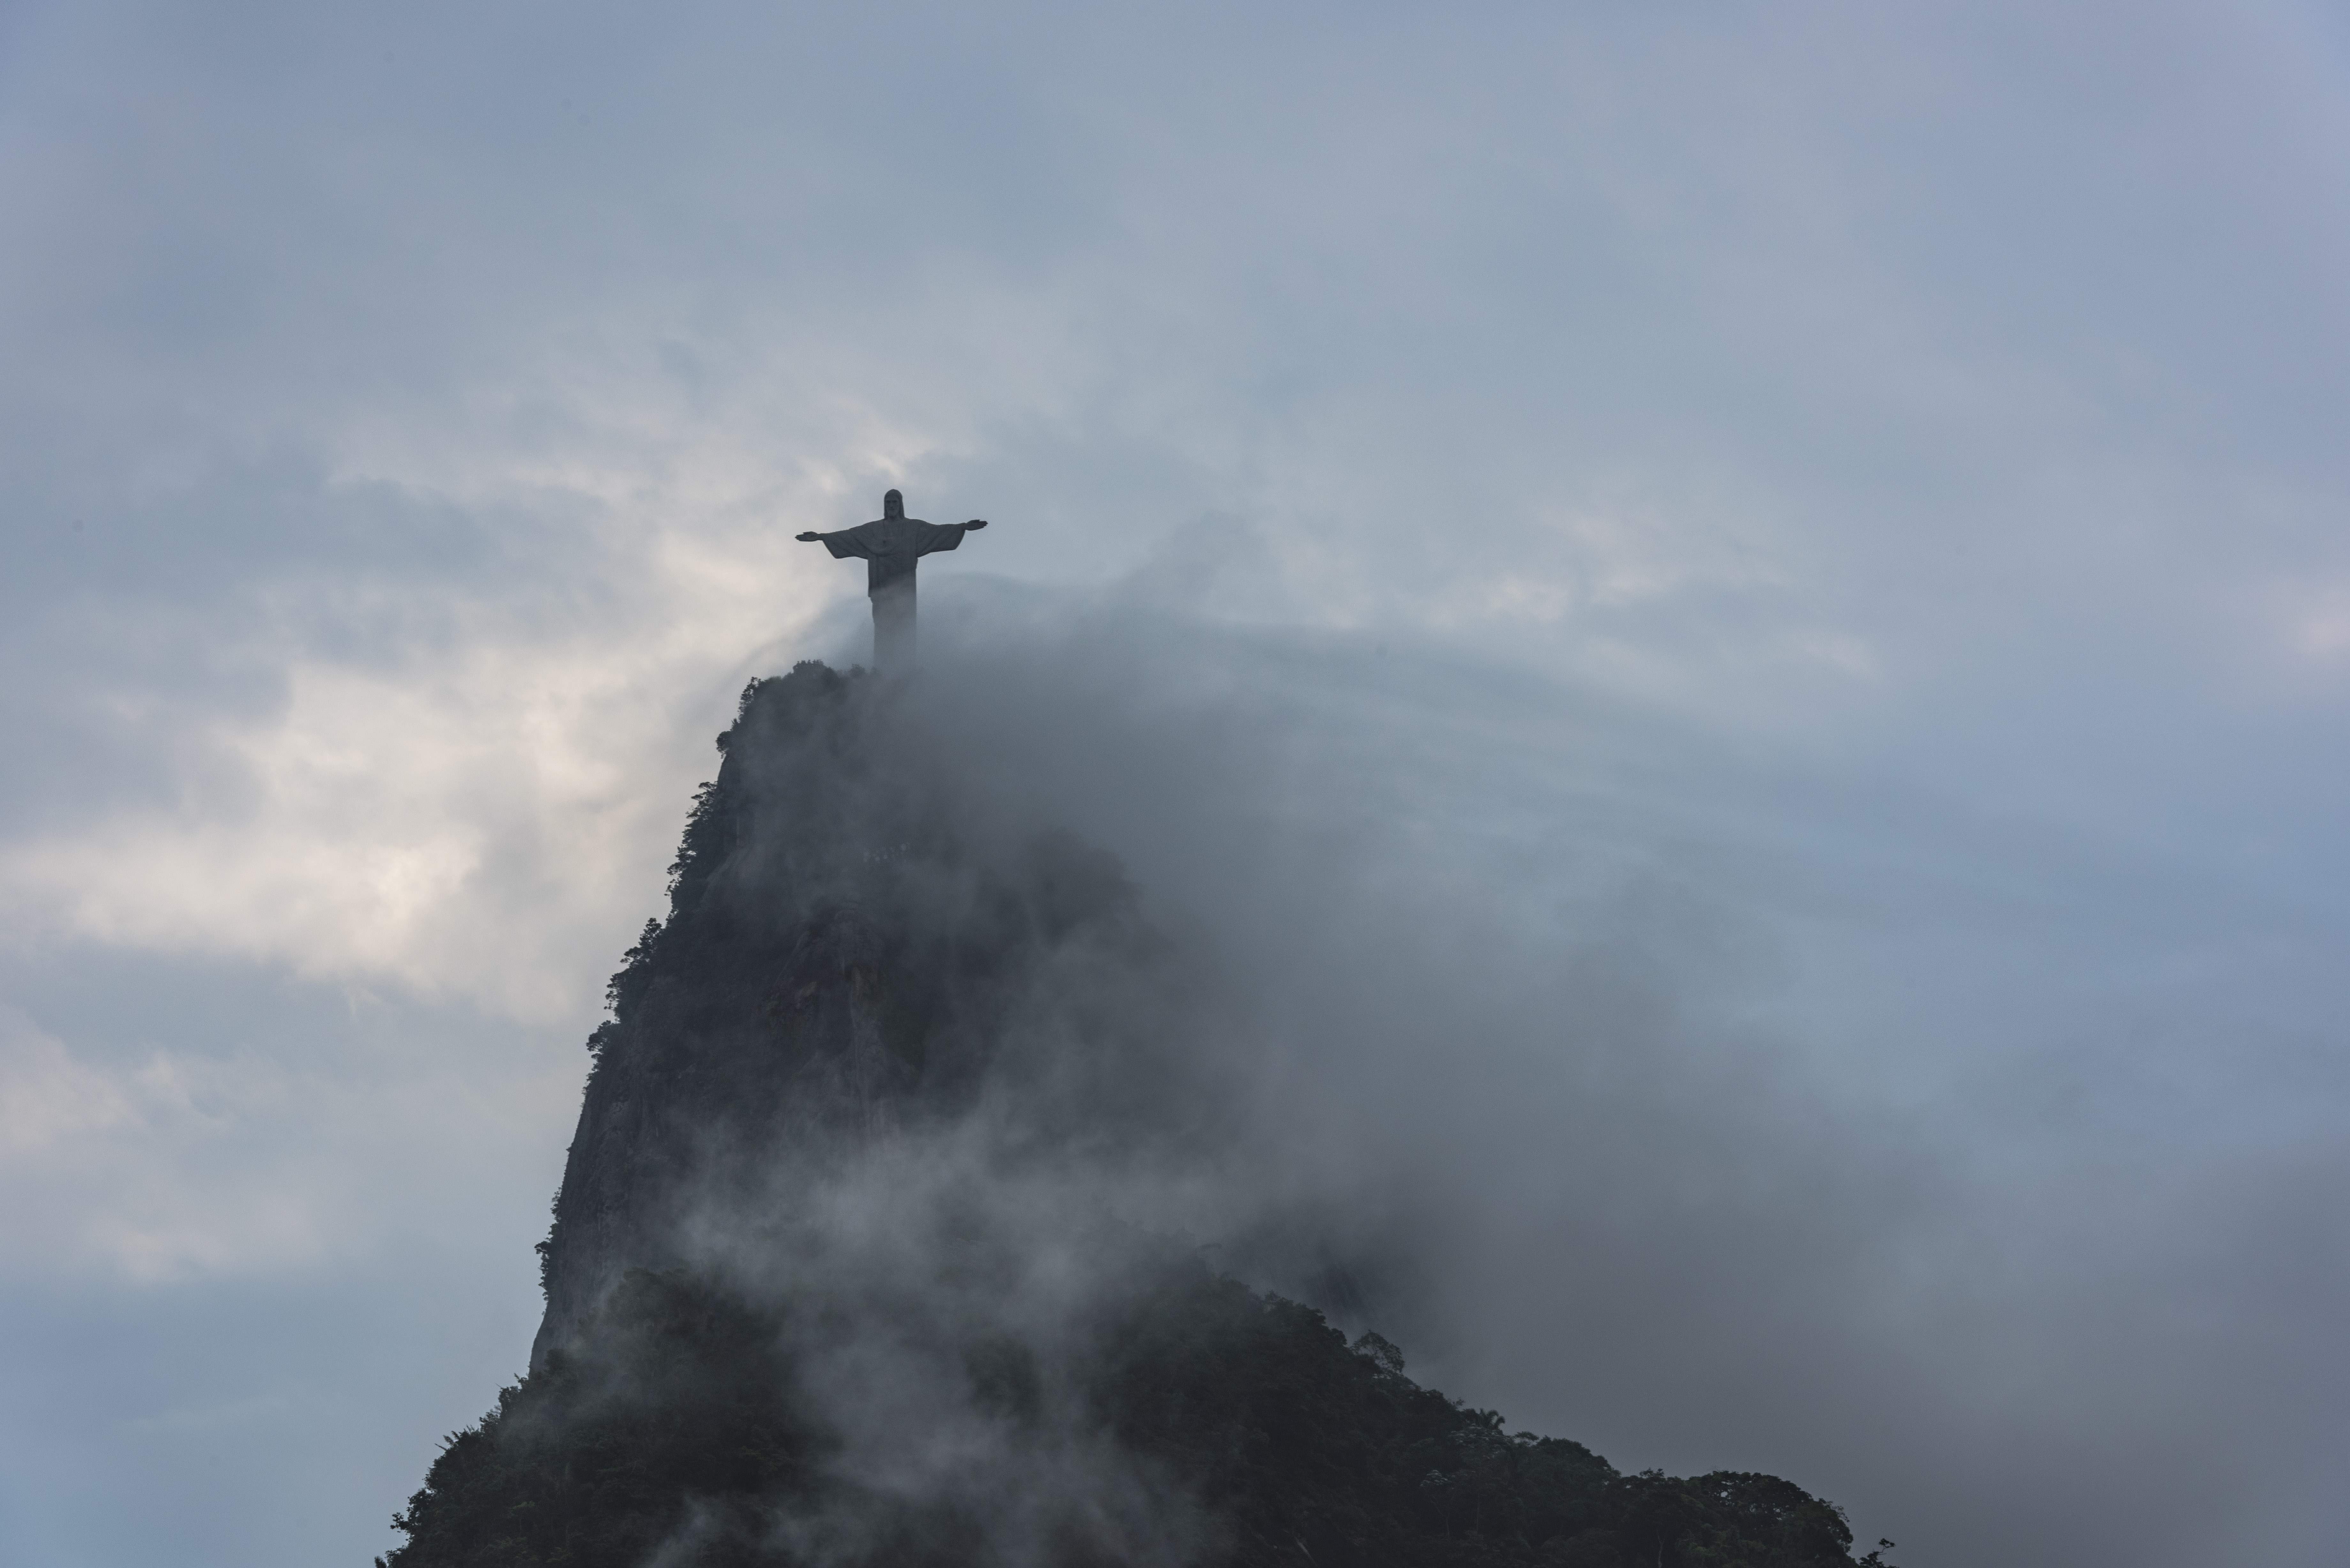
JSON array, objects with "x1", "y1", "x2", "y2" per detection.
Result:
[{"x1": 531, "y1": 663, "x2": 1163, "y2": 1368}]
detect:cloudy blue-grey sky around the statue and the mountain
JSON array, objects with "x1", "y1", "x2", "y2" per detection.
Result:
[{"x1": 0, "y1": 0, "x2": 2350, "y2": 1568}]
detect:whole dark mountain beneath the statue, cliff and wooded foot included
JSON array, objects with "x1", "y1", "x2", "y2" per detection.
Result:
[{"x1": 378, "y1": 663, "x2": 1878, "y2": 1568}]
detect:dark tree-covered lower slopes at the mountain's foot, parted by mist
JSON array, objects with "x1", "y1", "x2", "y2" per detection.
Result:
[{"x1": 388, "y1": 1246, "x2": 1880, "y2": 1568}]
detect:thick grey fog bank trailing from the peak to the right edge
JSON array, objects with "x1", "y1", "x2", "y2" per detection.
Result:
[{"x1": 761, "y1": 604, "x2": 2350, "y2": 1568}]
